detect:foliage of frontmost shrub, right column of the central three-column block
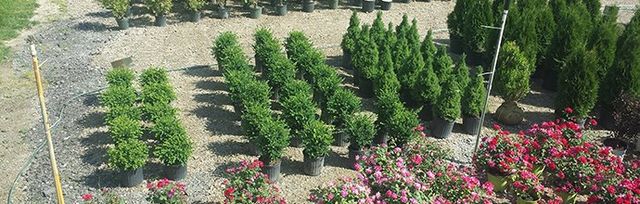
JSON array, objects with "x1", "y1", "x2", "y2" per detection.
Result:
[{"x1": 342, "y1": 113, "x2": 376, "y2": 150}]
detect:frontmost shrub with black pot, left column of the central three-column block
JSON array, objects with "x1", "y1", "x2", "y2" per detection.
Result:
[{"x1": 258, "y1": 119, "x2": 289, "y2": 182}]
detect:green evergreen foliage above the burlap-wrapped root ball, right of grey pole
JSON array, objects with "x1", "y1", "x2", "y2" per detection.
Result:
[{"x1": 494, "y1": 42, "x2": 532, "y2": 101}]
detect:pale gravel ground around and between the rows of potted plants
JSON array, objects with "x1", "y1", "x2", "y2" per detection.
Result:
[{"x1": 6, "y1": 0, "x2": 637, "y2": 203}]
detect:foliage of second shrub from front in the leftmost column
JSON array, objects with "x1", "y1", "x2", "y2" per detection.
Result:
[{"x1": 109, "y1": 116, "x2": 142, "y2": 145}]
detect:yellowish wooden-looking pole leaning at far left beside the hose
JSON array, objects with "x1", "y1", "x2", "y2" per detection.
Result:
[{"x1": 31, "y1": 44, "x2": 64, "y2": 204}]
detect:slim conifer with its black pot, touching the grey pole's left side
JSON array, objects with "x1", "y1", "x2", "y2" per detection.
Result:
[{"x1": 462, "y1": 66, "x2": 487, "y2": 135}]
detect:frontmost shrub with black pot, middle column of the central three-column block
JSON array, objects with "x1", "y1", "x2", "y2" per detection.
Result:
[{"x1": 301, "y1": 120, "x2": 333, "y2": 176}]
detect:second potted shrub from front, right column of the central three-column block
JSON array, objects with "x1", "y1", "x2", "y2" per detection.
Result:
[{"x1": 322, "y1": 88, "x2": 362, "y2": 147}]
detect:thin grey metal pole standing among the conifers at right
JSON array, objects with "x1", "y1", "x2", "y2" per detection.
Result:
[{"x1": 473, "y1": 0, "x2": 510, "y2": 154}]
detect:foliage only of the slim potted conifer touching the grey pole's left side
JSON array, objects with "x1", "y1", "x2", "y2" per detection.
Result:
[{"x1": 462, "y1": 66, "x2": 487, "y2": 117}]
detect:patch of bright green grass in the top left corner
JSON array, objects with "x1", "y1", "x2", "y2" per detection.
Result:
[{"x1": 0, "y1": 0, "x2": 38, "y2": 62}]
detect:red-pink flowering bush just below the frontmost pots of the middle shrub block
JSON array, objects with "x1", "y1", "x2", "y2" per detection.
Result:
[{"x1": 224, "y1": 160, "x2": 286, "y2": 204}]
